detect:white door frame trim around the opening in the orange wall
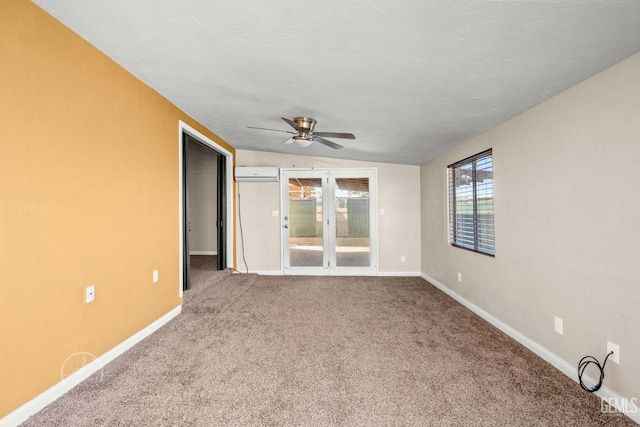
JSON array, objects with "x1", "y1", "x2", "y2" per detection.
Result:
[{"x1": 178, "y1": 120, "x2": 235, "y2": 297}]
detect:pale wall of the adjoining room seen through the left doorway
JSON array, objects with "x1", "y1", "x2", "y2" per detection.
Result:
[{"x1": 187, "y1": 143, "x2": 218, "y2": 255}]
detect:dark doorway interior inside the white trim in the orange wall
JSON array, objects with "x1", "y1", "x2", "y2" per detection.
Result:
[{"x1": 182, "y1": 132, "x2": 227, "y2": 290}]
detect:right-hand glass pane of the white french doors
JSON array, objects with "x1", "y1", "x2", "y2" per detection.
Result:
[{"x1": 334, "y1": 178, "x2": 371, "y2": 267}]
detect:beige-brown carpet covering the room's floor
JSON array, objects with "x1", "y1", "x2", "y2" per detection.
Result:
[{"x1": 24, "y1": 262, "x2": 635, "y2": 426}]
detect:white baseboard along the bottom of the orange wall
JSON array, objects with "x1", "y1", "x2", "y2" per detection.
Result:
[{"x1": 0, "y1": 305, "x2": 182, "y2": 427}]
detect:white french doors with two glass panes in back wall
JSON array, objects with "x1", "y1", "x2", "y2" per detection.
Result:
[{"x1": 280, "y1": 169, "x2": 378, "y2": 275}]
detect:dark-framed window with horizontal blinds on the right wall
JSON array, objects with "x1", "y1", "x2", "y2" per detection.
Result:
[{"x1": 448, "y1": 150, "x2": 495, "y2": 256}]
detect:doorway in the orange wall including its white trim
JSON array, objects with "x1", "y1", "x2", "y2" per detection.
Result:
[{"x1": 180, "y1": 122, "x2": 233, "y2": 296}]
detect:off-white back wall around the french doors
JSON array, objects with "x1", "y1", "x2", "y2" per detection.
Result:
[{"x1": 236, "y1": 148, "x2": 420, "y2": 274}]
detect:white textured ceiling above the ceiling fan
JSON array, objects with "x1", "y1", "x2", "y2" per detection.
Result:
[{"x1": 34, "y1": 0, "x2": 640, "y2": 164}]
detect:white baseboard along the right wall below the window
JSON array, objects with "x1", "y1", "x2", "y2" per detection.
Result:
[{"x1": 421, "y1": 273, "x2": 640, "y2": 424}]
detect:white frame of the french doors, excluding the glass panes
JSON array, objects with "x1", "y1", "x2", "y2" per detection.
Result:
[{"x1": 280, "y1": 168, "x2": 379, "y2": 276}]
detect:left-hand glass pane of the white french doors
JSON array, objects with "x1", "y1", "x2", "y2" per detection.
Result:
[{"x1": 288, "y1": 177, "x2": 324, "y2": 267}]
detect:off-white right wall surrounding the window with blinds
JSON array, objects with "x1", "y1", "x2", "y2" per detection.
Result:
[{"x1": 420, "y1": 54, "x2": 640, "y2": 399}]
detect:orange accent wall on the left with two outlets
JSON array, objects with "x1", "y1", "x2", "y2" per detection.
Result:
[{"x1": 0, "y1": 0, "x2": 235, "y2": 418}]
